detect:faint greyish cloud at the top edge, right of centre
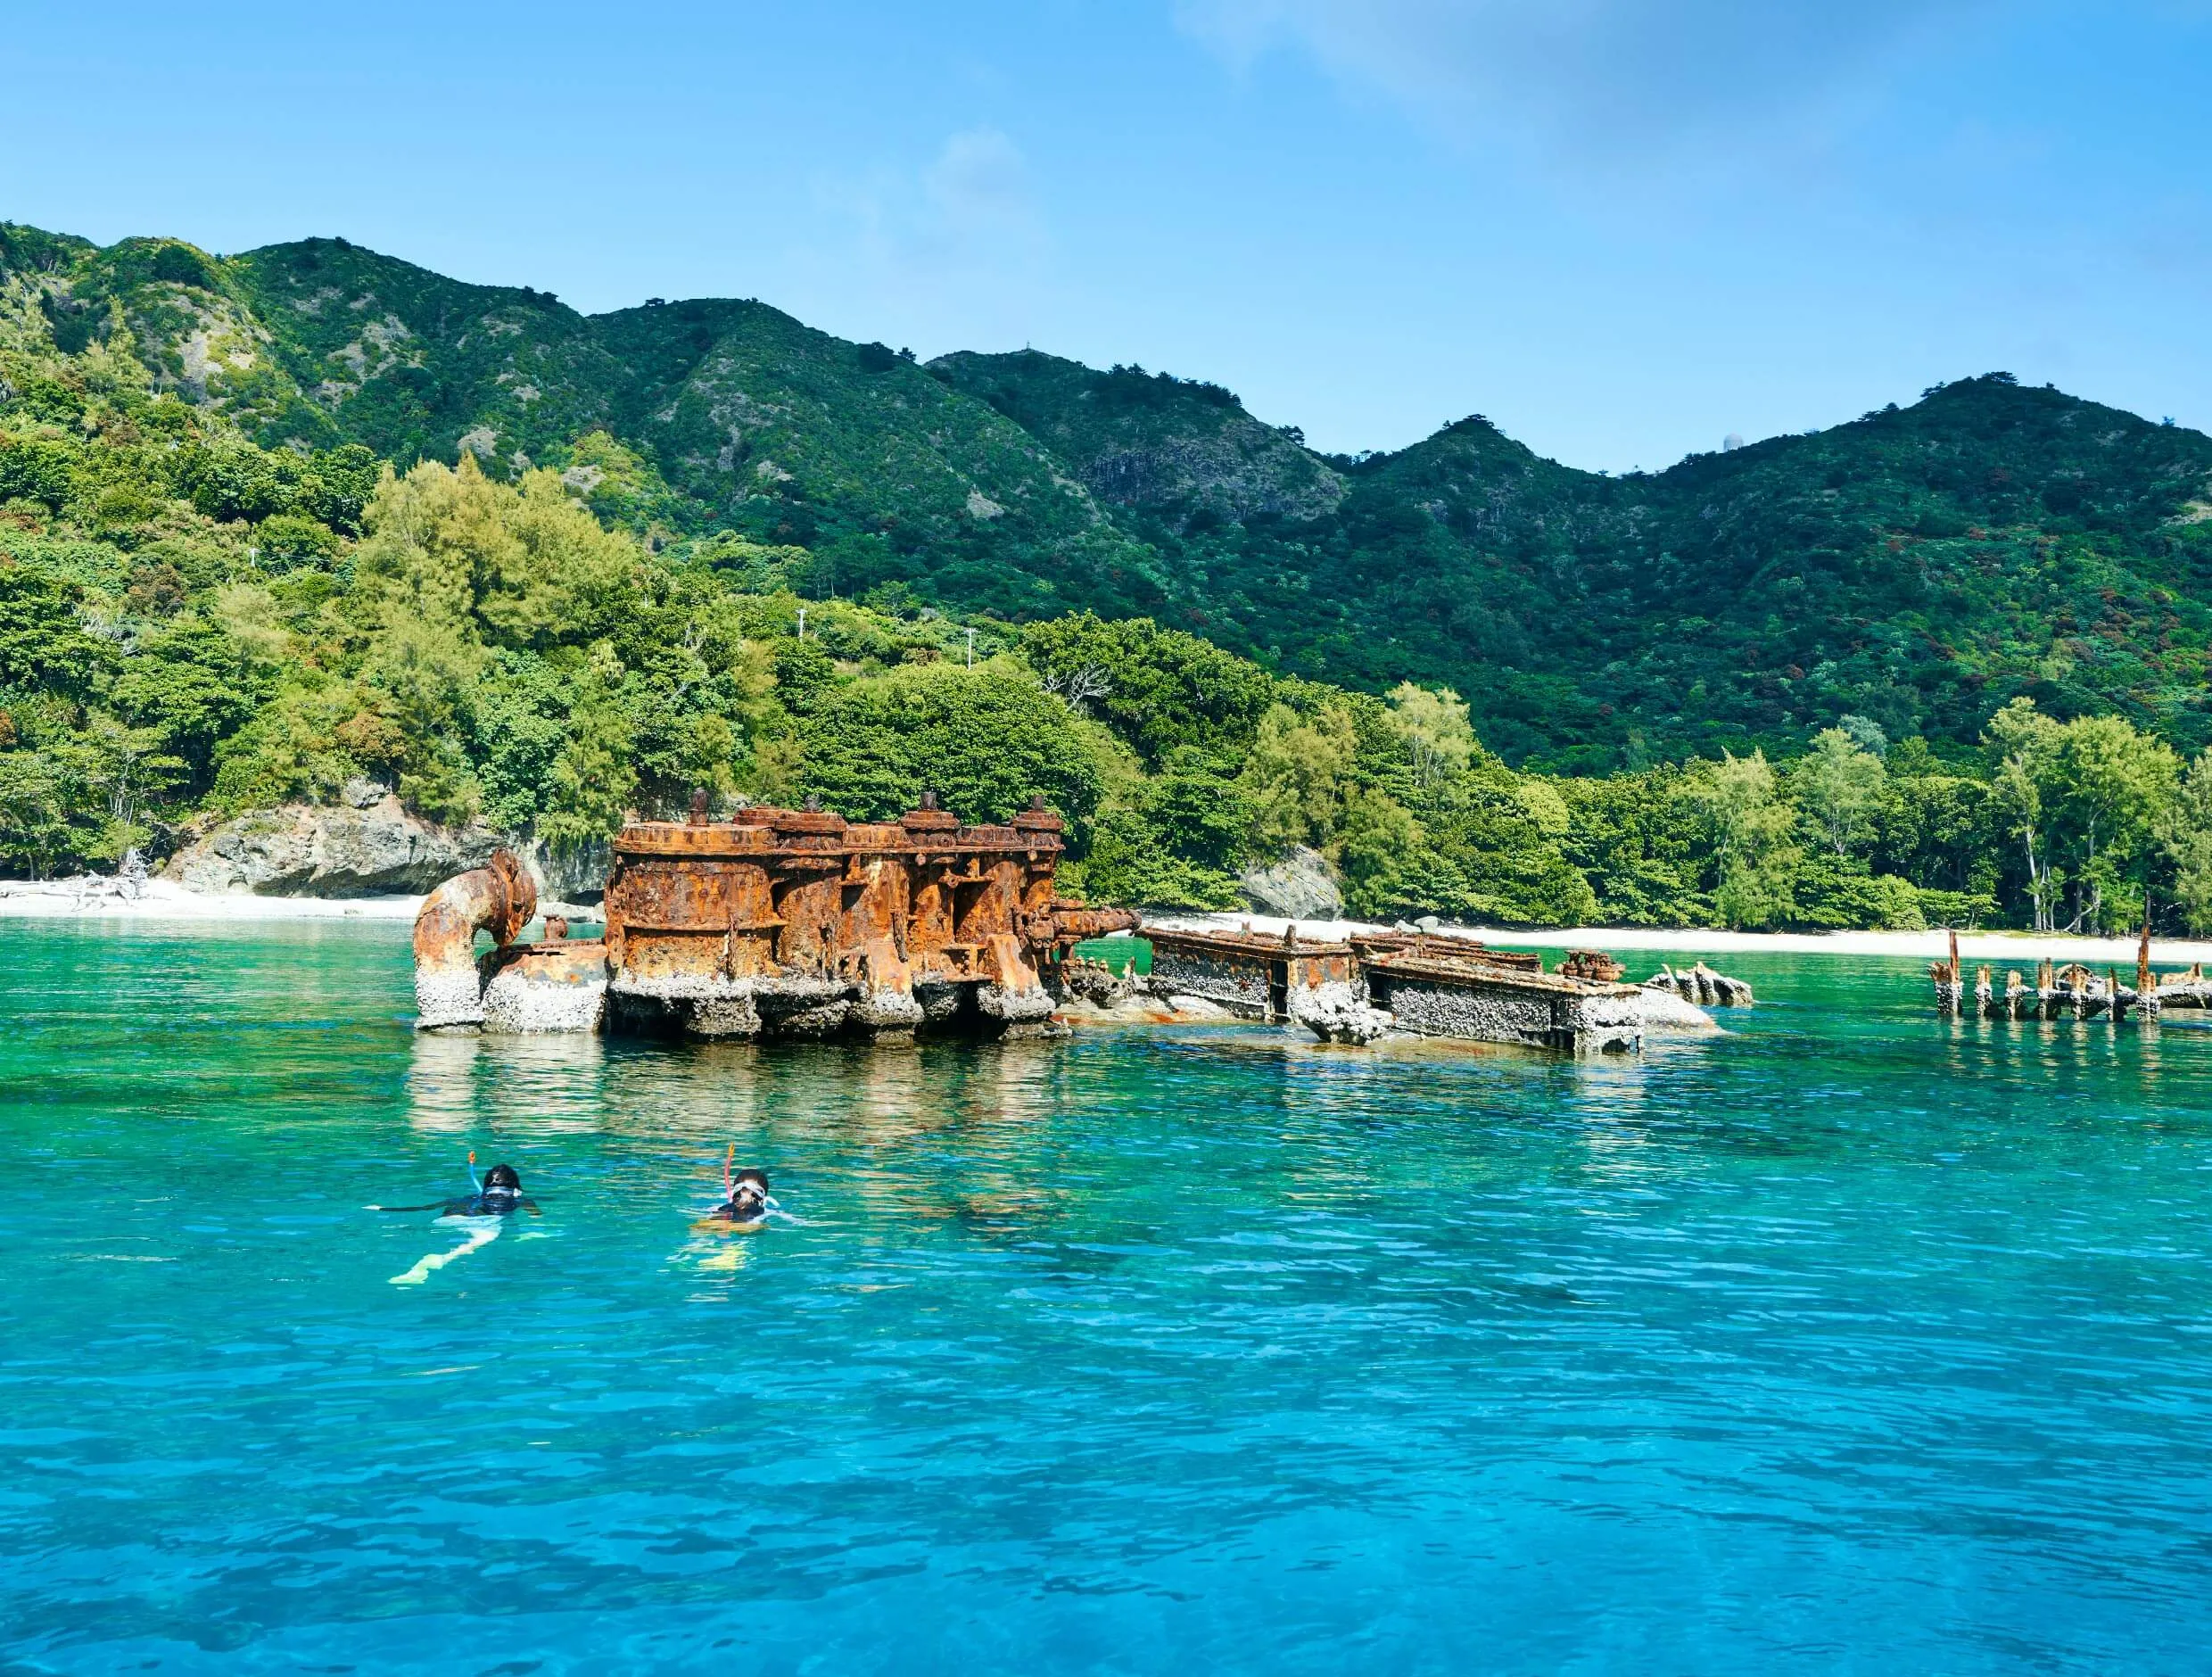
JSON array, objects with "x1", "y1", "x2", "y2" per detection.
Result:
[{"x1": 1176, "y1": 0, "x2": 2009, "y2": 166}]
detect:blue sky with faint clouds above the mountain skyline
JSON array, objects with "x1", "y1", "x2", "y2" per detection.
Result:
[{"x1": 0, "y1": 0, "x2": 2212, "y2": 471}]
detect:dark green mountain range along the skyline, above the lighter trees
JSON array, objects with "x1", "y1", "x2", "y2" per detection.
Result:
[{"x1": 0, "y1": 227, "x2": 2212, "y2": 772}]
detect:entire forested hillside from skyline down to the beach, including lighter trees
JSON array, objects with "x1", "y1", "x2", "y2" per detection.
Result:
[{"x1": 0, "y1": 226, "x2": 2212, "y2": 946}]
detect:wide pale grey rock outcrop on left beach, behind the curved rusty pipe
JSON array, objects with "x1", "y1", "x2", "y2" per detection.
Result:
[{"x1": 161, "y1": 796, "x2": 499, "y2": 896}]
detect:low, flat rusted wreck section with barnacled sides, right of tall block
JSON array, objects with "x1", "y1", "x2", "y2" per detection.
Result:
[{"x1": 1146, "y1": 927, "x2": 1644, "y2": 1053}]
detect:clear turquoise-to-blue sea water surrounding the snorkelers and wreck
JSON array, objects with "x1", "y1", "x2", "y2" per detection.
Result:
[{"x1": 0, "y1": 925, "x2": 2212, "y2": 1677}]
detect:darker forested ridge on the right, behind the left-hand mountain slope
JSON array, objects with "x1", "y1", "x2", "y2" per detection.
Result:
[{"x1": 936, "y1": 354, "x2": 2212, "y2": 770}]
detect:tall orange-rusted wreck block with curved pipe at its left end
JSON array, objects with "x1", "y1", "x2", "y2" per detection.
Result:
[{"x1": 414, "y1": 797, "x2": 1137, "y2": 1040}]
